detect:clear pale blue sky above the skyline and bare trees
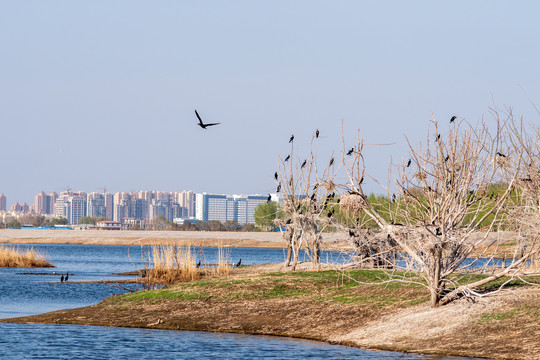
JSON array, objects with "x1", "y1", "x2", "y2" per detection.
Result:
[{"x1": 0, "y1": 0, "x2": 540, "y2": 204}]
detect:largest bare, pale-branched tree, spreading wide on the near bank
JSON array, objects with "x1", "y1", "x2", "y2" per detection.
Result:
[{"x1": 326, "y1": 114, "x2": 538, "y2": 307}]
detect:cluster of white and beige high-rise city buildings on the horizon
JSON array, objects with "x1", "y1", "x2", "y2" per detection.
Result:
[{"x1": 0, "y1": 189, "x2": 281, "y2": 224}]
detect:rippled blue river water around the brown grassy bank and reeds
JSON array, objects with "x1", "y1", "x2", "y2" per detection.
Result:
[{"x1": 0, "y1": 244, "x2": 480, "y2": 359}]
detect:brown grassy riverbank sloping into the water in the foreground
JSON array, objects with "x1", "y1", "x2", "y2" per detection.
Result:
[{"x1": 2, "y1": 264, "x2": 540, "y2": 359}]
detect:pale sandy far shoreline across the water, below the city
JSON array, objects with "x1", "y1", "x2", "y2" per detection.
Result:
[{"x1": 0, "y1": 229, "x2": 345, "y2": 248}]
